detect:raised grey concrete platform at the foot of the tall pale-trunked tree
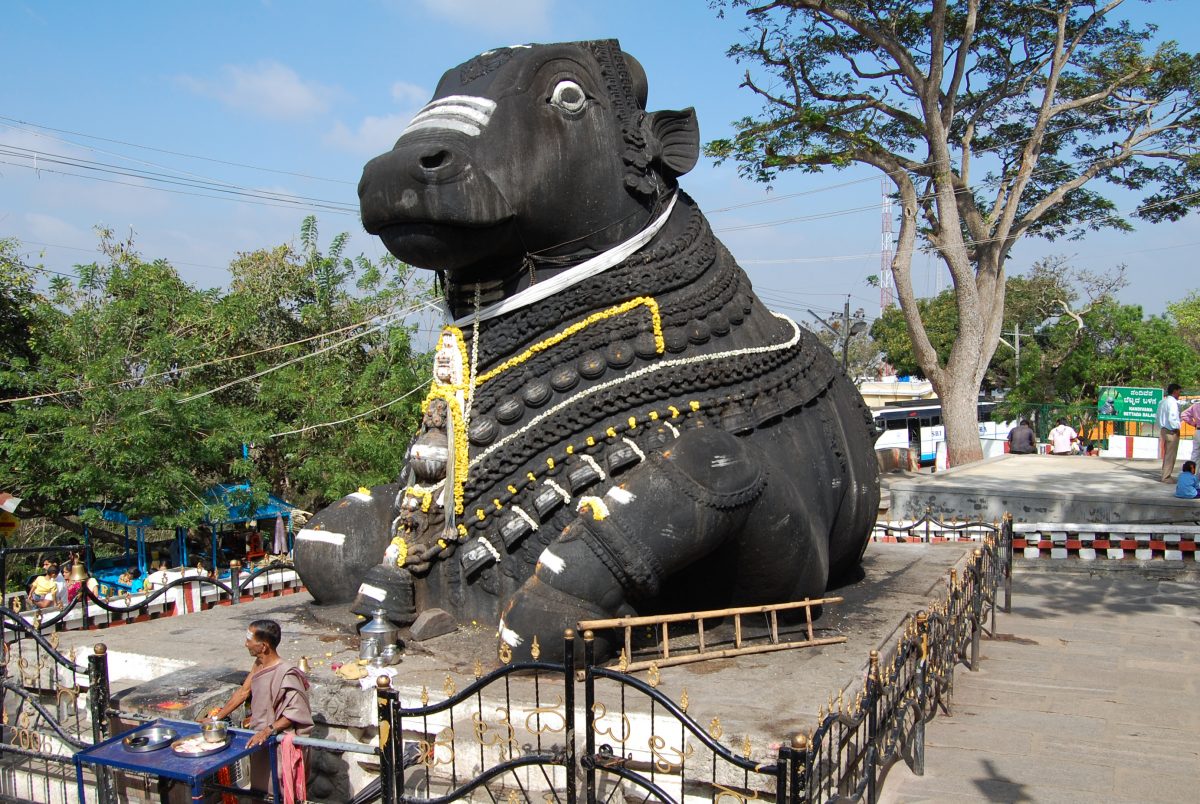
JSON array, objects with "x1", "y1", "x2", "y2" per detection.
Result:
[{"x1": 884, "y1": 455, "x2": 1200, "y2": 523}]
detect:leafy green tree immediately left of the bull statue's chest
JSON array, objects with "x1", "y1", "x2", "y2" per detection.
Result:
[{"x1": 222, "y1": 217, "x2": 431, "y2": 510}]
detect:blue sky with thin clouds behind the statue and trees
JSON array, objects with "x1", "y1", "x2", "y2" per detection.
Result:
[{"x1": 0, "y1": 0, "x2": 1200, "y2": 319}]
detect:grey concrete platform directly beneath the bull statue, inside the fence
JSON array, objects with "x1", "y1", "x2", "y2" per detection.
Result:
[{"x1": 60, "y1": 544, "x2": 973, "y2": 782}]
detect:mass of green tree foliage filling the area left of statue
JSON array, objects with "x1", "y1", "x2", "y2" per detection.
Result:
[{"x1": 0, "y1": 218, "x2": 427, "y2": 535}]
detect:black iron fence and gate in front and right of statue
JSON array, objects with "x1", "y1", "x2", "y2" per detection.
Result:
[{"x1": 377, "y1": 517, "x2": 1013, "y2": 804}]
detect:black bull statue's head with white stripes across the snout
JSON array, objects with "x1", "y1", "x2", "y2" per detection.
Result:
[{"x1": 359, "y1": 40, "x2": 700, "y2": 302}]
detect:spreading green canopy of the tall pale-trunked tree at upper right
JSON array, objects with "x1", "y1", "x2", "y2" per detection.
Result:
[{"x1": 706, "y1": 0, "x2": 1200, "y2": 239}]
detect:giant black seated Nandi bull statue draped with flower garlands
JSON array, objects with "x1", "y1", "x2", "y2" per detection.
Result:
[{"x1": 296, "y1": 41, "x2": 878, "y2": 658}]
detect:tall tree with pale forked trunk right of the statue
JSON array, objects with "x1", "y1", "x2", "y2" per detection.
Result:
[{"x1": 707, "y1": 0, "x2": 1200, "y2": 463}]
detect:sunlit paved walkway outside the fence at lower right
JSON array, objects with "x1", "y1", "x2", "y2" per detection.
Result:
[{"x1": 882, "y1": 572, "x2": 1200, "y2": 804}]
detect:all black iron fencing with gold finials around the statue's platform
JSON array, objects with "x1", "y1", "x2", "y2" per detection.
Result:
[{"x1": 0, "y1": 517, "x2": 1012, "y2": 804}]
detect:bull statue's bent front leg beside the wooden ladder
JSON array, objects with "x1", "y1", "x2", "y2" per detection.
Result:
[{"x1": 499, "y1": 428, "x2": 824, "y2": 661}]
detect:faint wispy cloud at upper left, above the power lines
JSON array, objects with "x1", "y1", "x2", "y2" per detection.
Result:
[{"x1": 179, "y1": 61, "x2": 337, "y2": 120}]
